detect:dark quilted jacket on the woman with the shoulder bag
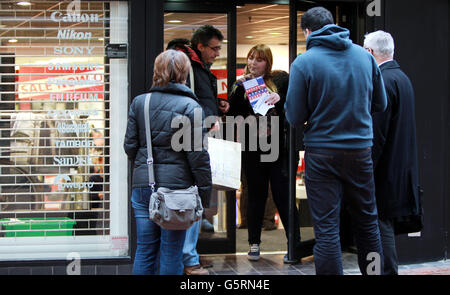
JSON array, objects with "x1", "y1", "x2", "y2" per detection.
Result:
[{"x1": 124, "y1": 83, "x2": 212, "y2": 207}]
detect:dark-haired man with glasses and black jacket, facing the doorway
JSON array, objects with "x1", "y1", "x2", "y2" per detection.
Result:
[{"x1": 167, "y1": 25, "x2": 229, "y2": 275}]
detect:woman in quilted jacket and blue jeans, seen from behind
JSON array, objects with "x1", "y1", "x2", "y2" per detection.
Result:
[{"x1": 124, "y1": 50, "x2": 212, "y2": 275}]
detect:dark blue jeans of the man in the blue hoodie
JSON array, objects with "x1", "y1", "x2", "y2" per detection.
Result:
[{"x1": 305, "y1": 147, "x2": 383, "y2": 275}]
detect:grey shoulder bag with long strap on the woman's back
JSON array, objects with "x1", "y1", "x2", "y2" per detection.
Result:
[{"x1": 144, "y1": 93, "x2": 203, "y2": 230}]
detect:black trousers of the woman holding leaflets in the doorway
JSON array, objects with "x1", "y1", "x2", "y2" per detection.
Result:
[{"x1": 242, "y1": 152, "x2": 300, "y2": 247}]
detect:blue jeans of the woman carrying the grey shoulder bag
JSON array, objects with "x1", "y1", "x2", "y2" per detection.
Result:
[{"x1": 131, "y1": 188, "x2": 186, "y2": 275}]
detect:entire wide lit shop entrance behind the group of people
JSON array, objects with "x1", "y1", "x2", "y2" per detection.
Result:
[{"x1": 164, "y1": 1, "x2": 364, "y2": 254}]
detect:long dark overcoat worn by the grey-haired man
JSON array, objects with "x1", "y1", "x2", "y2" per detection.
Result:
[{"x1": 372, "y1": 60, "x2": 421, "y2": 219}]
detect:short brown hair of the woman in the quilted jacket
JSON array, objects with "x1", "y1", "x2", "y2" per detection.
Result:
[{"x1": 153, "y1": 49, "x2": 191, "y2": 86}]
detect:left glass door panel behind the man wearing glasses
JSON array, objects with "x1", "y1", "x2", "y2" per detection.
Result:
[{"x1": 164, "y1": 1, "x2": 236, "y2": 254}]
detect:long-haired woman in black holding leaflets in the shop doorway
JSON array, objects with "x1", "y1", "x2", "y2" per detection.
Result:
[{"x1": 228, "y1": 44, "x2": 300, "y2": 261}]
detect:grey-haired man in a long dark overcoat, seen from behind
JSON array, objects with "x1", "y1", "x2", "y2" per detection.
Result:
[{"x1": 364, "y1": 31, "x2": 422, "y2": 275}]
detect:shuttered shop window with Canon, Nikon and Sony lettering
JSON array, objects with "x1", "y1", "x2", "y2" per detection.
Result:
[{"x1": 0, "y1": 0, "x2": 128, "y2": 260}]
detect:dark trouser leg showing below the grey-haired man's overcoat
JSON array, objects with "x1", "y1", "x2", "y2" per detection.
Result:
[{"x1": 378, "y1": 219, "x2": 398, "y2": 275}]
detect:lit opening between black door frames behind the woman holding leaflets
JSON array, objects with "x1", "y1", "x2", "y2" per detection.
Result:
[{"x1": 236, "y1": 3, "x2": 289, "y2": 253}]
